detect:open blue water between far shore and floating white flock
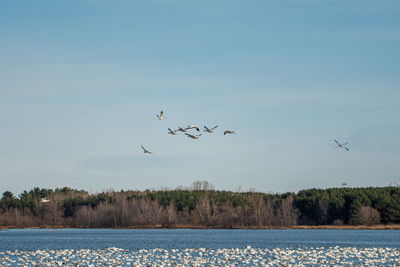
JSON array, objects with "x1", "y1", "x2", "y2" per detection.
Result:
[{"x1": 0, "y1": 229, "x2": 400, "y2": 251}]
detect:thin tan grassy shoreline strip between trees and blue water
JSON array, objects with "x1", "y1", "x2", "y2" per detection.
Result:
[{"x1": 0, "y1": 224, "x2": 400, "y2": 230}]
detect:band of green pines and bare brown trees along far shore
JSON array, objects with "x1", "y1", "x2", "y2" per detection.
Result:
[{"x1": 0, "y1": 181, "x2": 400, "y2": 228}]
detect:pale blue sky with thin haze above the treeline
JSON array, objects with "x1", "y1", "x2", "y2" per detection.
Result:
[{"x1": 0, "y1": 0, "x2": 400, "y2": 196}]
